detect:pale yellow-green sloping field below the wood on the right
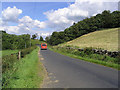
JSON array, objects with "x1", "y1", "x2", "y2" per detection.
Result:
[{"x1": 60, "y1": 28, "x2": 120, "y2": 51}]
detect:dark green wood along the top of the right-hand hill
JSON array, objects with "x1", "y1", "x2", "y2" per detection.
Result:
[{"x1": 45, "y1": 10, "x2": 120, "y2": 45}]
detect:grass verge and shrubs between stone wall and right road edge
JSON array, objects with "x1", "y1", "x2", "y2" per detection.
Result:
[{"x1": 49, "y1": 46, "x2": 120, "y2": 70}]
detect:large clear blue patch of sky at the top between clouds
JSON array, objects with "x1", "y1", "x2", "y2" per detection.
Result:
[{"x1": 2, "y1": 2, "x2": 73, "y2": 21}]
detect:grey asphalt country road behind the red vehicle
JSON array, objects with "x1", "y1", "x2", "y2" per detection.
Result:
[{"x1": 40, "y1": 49, "x2": 118, "y2": 88}]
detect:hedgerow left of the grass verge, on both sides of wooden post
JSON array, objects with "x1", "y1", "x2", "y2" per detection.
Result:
[{"x1": 2, "y1": 47, "x2": 36, "y2": 87}]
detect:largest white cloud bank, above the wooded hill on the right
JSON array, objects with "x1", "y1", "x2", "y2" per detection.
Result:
[{"x1": 44, "y1": 0, "x2": 117, "y2": 31}]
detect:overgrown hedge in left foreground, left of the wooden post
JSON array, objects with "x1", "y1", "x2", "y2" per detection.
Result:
[{"x1": 2, "y1": 54, "x2": 18, "y2": 87}]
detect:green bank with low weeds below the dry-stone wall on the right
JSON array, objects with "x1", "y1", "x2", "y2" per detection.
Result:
[{"x1": 49, "y1": 47, "x2": 120, "y2": 70}]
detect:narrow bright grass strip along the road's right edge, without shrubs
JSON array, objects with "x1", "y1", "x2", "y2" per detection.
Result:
[{"x1": 49, "y1": 46, "x2": 120, "y2": 70}]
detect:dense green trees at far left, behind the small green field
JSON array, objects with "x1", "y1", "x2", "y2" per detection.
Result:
[{"x1": 2, "y1": 31, "x2": 30, "y2": 50}]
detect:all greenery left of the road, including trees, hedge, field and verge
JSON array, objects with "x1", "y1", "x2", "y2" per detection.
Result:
[{"x1": 0, "y1": 31, "x2": 44, "y2": 88}]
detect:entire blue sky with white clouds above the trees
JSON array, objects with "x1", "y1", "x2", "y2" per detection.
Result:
[{"x1": 0, "y1": 0, "x2": 119, "y2": 38}]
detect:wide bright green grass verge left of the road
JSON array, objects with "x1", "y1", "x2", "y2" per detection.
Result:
[{"x1": 6, "y1": 47, "x2": 44, "y2": 88}]
